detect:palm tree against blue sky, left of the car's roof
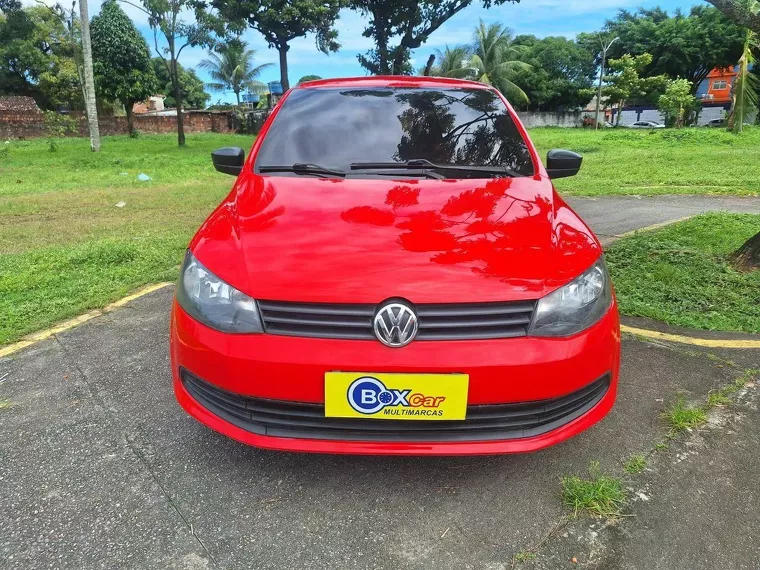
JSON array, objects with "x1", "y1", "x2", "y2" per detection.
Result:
[{"x1": 198, "y1": 39, "x2": 272, "y2": 105}]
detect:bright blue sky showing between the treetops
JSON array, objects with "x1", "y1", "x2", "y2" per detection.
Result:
[{"x1": 25, "y1": 0, "x2": 702, "y2": 103}]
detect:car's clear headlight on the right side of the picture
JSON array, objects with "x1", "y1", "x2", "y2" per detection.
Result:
[{"x1": 528, "y1": 257, "x2": 612, "y2": 336}]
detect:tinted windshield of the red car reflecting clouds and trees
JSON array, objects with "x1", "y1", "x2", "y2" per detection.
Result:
[{"x1": 256, "y1": 87, "x2": 533, "y2": 176}]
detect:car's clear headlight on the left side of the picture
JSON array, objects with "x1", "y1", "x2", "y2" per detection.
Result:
[{"x1": 177, "y1": 251, "x2": 264, "y2": 333}]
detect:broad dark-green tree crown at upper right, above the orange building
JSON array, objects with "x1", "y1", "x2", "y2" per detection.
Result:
[{"x1": 596, "y1": 6, "x2": 744, "y2": 93}]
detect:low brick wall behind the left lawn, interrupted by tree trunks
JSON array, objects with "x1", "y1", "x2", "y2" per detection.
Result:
[{"x1": 0, "y1": 111, "x2": 232, "y2": 140}]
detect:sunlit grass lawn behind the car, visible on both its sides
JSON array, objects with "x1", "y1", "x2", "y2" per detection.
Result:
[{"x1": 0, "y1": 128, "x2": 760, "y2": 345}]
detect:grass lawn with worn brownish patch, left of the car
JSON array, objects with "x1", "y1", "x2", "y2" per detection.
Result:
[{"x1": 0, "y1": 134, "x2": 253, "y2": 345}]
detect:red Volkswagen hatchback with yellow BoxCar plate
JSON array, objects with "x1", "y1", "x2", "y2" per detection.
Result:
[{"x1": 171, "y1": 77, "x2": 620, "y2": 455}]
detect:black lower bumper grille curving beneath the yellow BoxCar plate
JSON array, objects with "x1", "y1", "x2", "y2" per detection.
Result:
[{"x1": 180, "y1": 369, "x2": 610, "y2": 442}]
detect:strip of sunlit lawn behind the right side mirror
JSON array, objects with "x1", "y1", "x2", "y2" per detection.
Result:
[{"x1": 530, "y1": 127, "x2": 760, "y2": 196}]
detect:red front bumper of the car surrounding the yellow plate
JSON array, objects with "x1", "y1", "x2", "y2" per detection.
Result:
[{"x1": 171, "y1": 302, "x2": 620, "y2": 455}]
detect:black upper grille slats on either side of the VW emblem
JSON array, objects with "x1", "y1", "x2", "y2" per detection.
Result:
[{"x1": 259, "y1": 301, "x2": 535, "y2": 340}]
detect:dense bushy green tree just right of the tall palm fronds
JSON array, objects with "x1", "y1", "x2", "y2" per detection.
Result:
[{"x1": 514, "y1": 36, "x2": 596, "y2": 111}]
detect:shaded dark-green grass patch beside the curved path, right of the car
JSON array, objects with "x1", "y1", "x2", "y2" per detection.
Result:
[{"x1": 607, "y1": 213, "x2": 760, "y2": 333}]
